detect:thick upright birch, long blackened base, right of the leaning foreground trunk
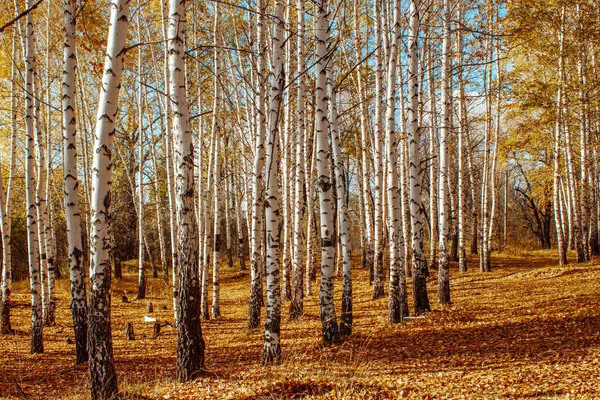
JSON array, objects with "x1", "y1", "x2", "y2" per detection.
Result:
[{"x1": 168, "y1": 0, "x2": 205, "y2": 382}]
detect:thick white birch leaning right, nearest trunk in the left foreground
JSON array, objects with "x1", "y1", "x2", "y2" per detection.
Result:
[{"x1": 88, "y1": 0, "x2": 130, "y2": 400}]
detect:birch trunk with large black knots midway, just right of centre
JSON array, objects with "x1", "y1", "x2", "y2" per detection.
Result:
[{"x1": 315, "y1": 0, "x2": 338, "y2": 342}]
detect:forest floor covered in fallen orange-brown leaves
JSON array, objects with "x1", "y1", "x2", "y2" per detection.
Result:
[{"x1": 0, "y1": 248, "x2": 600, "y2": 399}]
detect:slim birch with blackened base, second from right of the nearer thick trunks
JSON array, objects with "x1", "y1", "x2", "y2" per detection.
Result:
[{"x1": 408, "y1": 0, "x2": 430, "y2": 314}]
